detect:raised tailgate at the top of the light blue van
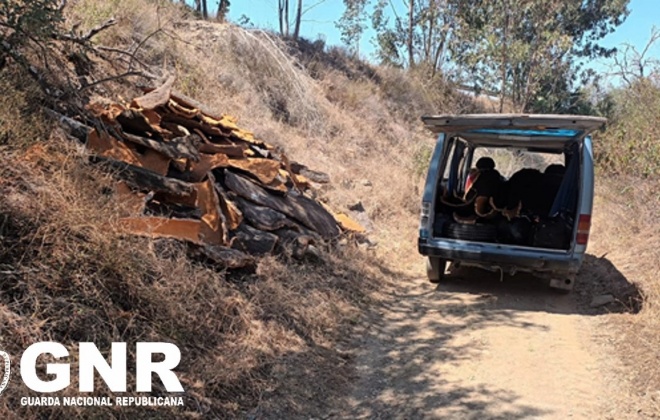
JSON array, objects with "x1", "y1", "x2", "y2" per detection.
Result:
[{"x1": 422, "y1": 114, "x2": 607, "y2": 138}]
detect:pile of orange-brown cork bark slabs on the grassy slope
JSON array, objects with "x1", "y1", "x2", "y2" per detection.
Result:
[{"x1": 87, "y1": 78, "x2": 364, "y2": 268}]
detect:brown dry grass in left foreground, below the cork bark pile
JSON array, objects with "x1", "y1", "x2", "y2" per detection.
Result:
[{"x1": 0, "y1": 64, "x2": 383, "y2": 418}]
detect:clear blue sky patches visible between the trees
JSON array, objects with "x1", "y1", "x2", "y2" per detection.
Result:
[{"x1": 224, "y1": 0, "x2": 660, "y2": 85}]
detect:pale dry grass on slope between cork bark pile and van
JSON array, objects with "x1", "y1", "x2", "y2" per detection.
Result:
[{"x1": 65, "y1": 5, "x2": 473, "y2": 270}]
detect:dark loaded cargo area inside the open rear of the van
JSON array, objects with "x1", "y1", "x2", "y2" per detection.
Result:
[{"x1": 433, "y1": 137, "x2": 580, "y2": 250}]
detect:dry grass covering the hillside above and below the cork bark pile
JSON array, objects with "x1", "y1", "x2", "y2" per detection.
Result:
[{"x1": 0, "y1": 0, "x2": 448, "y2": 418}]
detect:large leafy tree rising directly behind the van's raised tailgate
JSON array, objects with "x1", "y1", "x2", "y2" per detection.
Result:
[{"x1": 452, "y1": 0, "x2": 628, "y2": 111}]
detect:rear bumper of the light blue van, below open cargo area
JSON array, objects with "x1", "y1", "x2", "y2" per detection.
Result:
[{"x1": 418, "y1": 239, "x2": 583, "y2": 274}]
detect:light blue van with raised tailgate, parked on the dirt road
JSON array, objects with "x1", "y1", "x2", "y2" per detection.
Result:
[{"x1": 418, "y1": 114, "x2": 606, "y2": 290}]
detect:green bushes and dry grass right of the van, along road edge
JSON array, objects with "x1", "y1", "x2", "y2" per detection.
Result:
[{"x1": 594, "y1": 74, "x2": 660, "y2": 417}]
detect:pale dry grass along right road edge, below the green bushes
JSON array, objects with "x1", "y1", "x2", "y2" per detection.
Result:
[{"x1": 589, "y1": 177, "x2": 660, "y2": 417}]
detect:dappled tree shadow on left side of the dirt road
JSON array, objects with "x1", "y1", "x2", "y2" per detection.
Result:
[{"x1": 342, "y1": 278, "x2": 551, "y2": 419}]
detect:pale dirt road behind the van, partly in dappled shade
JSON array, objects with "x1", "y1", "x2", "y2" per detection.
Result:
[{"x1": 339, "y1": 257, "x2": 632, "y2": 419}]
